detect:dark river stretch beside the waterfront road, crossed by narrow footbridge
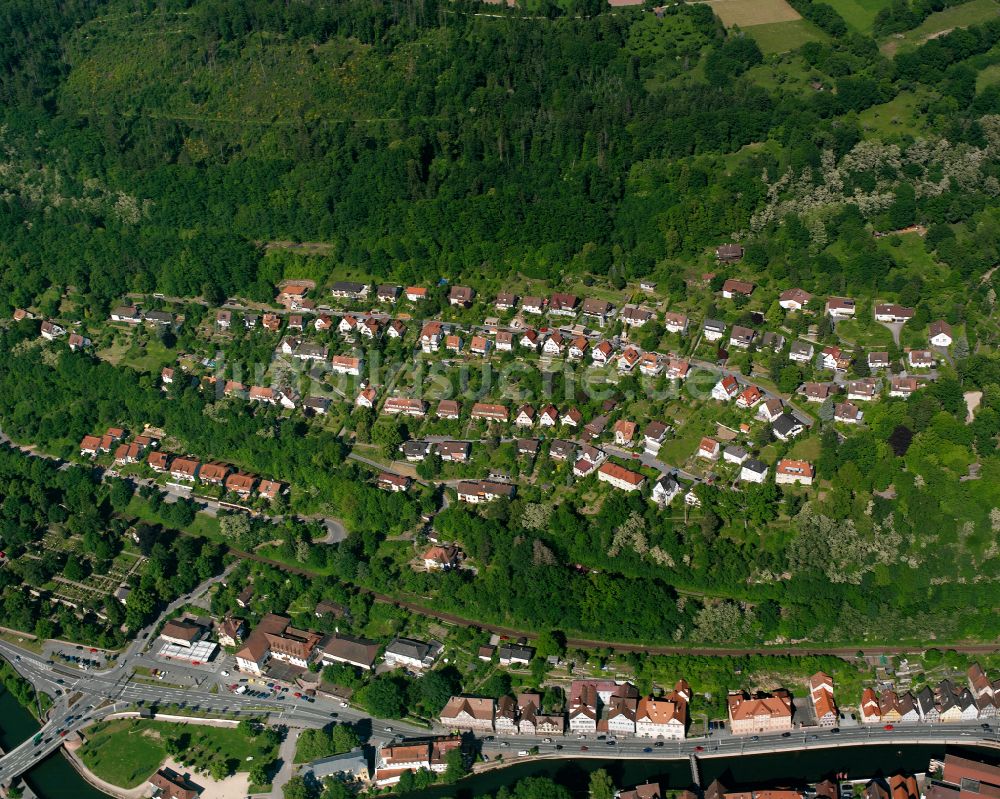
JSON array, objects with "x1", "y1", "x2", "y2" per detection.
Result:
[{"x1": 406, "y1": 745, "x2": 996, "y2": 799}]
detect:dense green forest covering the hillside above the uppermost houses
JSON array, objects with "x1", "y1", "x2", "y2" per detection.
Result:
[{"x1": 0, "y1": 0, "x2": 1000, "y2": 313}]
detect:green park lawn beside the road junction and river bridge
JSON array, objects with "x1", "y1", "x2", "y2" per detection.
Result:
[{"x1": 80, "y1": 719, "x2": 274, "y2": 788}]
